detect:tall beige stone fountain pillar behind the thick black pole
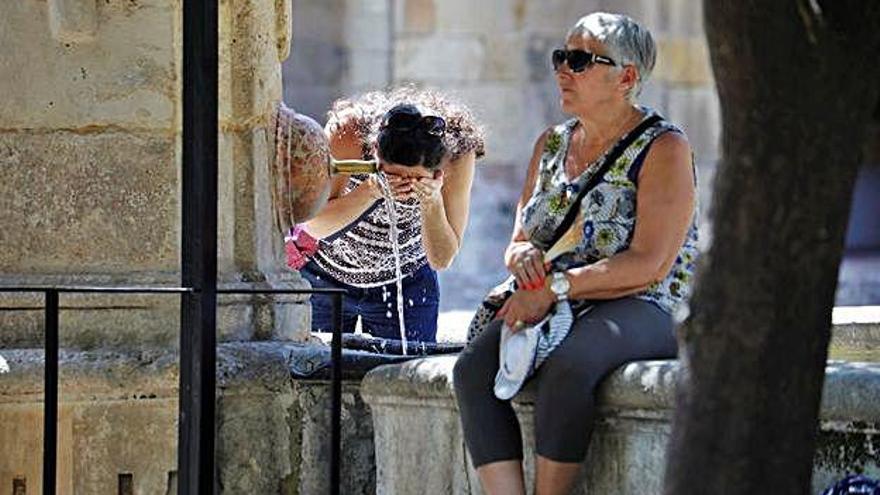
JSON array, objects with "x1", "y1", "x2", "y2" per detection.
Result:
[{"x1": 0, "y1": 0, "x2": 308, "y2": 348}]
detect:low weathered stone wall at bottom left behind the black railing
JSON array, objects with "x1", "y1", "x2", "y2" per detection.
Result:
[{"x1": 0, "y1": 343, "x2": 375, "y2": 495}]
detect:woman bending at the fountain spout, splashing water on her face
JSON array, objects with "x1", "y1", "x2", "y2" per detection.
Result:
[{"x1": 302, "y1": 87, "x2": 484, "y2": 342}]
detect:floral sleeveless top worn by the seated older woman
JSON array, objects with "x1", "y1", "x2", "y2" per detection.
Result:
[{"x1": 522, "y1": 108, "x2": 698, "y2": 314}]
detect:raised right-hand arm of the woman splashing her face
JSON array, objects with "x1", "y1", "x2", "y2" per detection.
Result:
[{"x1": 421, "y1": 152, "x2": 476, "y2": 270}]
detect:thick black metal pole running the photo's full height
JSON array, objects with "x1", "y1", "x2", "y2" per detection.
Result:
[{"x1": 177, "y1": 0, "x2": 219, "y2": 495}]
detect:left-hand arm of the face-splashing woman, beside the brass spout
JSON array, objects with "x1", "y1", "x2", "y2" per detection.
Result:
[{"x1": 305, "y1": 118, "x2": 382, "y2": 238}]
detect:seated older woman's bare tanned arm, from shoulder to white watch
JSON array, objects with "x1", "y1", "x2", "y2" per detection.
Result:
[{"x1": 567, "y1": 133, "x2": 696, "y2": 299}]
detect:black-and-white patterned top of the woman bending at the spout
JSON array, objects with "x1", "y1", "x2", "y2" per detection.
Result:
[{"x1": 312, "y1": 175, "x2": 428, "y2": 288}]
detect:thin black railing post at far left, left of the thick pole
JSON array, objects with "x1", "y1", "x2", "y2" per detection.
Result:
[{"x1": 43, "y1": 290, "x2": 58, "y2": 495}]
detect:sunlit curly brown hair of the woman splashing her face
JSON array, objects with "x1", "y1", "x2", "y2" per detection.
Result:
[{"x1": 327, "y1": 84, "x2": 486, "y2": 160}]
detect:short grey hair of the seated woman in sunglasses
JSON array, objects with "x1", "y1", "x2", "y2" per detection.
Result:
[{"x1": 566, "y1": 12, "x2": 657, "y2": 101}]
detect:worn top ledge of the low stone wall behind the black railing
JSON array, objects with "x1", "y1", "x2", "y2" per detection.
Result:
[{"x1": 0, "y1": 341, "x2": 422, "y2": 405}]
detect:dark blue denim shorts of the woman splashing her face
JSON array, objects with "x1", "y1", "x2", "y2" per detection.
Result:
[{"x1": 301, "y1": 262, "x2": 440, "y2": 342}]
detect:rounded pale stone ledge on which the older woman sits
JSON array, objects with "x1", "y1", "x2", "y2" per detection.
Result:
[{"x1": 361, "y1": 356, "x2": 880, "y2": 423}]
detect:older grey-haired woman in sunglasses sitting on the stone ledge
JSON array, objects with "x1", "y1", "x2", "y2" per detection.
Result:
[{"x1": 454, "y1": 13, "x2": 697, "y2": 495}]
